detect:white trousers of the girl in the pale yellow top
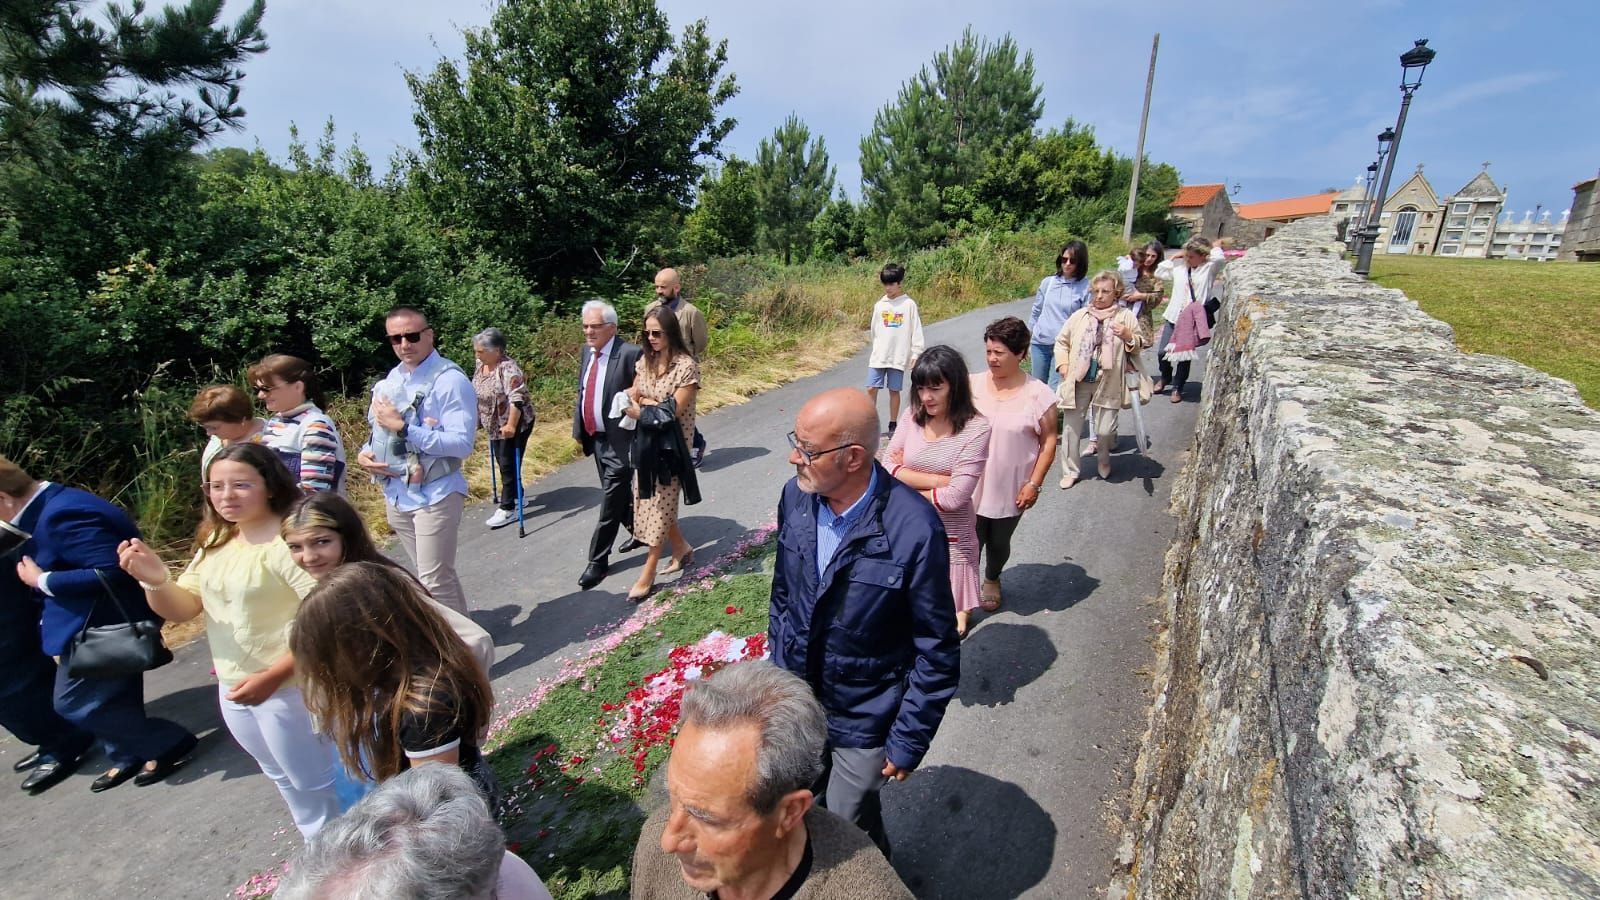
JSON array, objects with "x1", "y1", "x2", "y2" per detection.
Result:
[{"x1": 219, "y1": 685, "x2": 339, "y2": 839}]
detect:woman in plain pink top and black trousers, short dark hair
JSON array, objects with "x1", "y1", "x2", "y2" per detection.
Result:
[{"x1": 971, "y1": 315, "x2": 1059, "y2": 612}]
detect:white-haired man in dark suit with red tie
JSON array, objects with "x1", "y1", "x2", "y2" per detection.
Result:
[{"x1": 573, "y1": 299, "x2": 642, "y2": 591}]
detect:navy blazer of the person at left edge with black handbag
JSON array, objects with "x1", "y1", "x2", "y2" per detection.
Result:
[{"x1": 14, "y1": 484, "x2": 160, "y2": 657}]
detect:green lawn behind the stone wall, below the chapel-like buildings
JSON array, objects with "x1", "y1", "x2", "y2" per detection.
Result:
[{"x1": 1373, "y1": 256, "x2": 1600, "y2": 408}]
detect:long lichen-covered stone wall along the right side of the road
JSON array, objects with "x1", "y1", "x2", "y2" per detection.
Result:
[{"x1": 1112, "y1": 218, "x2": 1600, "y2": 900}]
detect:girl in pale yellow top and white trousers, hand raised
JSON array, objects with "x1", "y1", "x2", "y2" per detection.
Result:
[{"x1": 117, "y1": 444, "x2": 339, "y2": 838}]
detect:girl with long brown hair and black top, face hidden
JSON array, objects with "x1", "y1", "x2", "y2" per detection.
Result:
[{"x1": 290, "y1": 562, "x2": 498, "y2": 809}]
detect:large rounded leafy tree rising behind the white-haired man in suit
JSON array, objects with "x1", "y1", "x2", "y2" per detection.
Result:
[{"x1": 406, "y1": 0, "x2": 738, "y2": 293}]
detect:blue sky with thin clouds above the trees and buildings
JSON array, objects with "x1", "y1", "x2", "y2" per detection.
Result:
[{"x1": 212, "y1": 0, "x2": 1600, "y2": 213}]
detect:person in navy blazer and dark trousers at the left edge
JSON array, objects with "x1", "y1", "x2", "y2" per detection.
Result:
[{"x1": 0, "y1": 456, "x2": 197, "y2": 793}]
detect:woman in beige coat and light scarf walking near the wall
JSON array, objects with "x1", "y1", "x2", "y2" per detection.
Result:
[{"x1": 1054, "y1": 271, "x2": 1150, "y2": 490}]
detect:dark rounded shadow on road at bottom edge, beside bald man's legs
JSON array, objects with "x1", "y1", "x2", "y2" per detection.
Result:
[{"x1": 883, "y1": 765, "x2": 1056, "y2": 900}]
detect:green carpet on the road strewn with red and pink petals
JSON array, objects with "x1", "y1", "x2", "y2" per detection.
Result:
[{"x1": 488, "y1": 530, "x2": 773, "y2": 900}]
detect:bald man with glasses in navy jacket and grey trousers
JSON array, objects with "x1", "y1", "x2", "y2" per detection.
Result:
[{"x1": 768, "y1": 389, "x2": 962, "y2": 854}]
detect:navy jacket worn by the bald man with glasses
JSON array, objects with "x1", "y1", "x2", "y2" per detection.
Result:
[{"x1": 766, "y1": 463, "x2": 962, "y2": 770}]
